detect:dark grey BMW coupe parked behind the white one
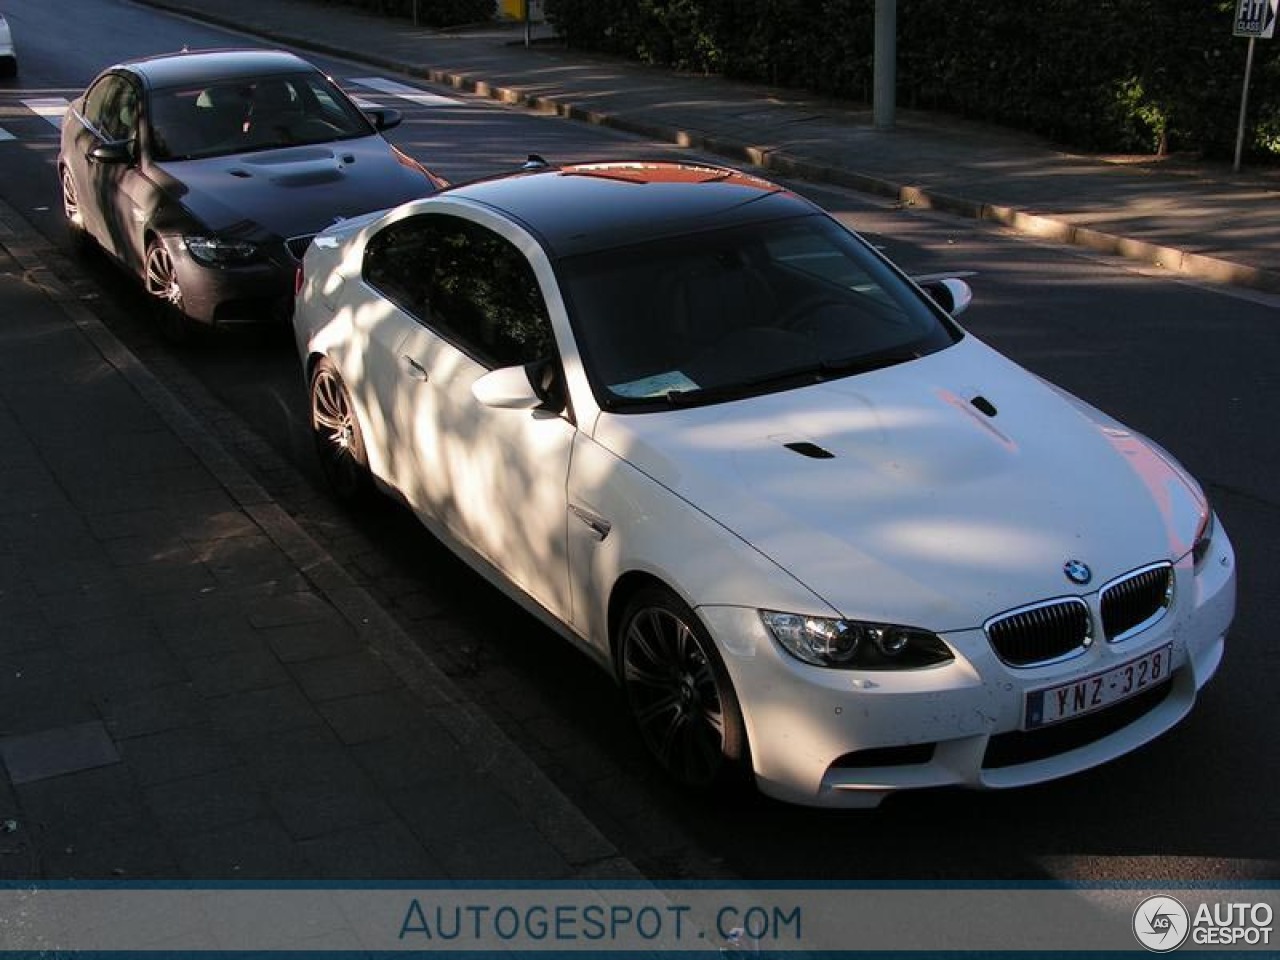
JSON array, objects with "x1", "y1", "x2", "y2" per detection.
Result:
[{"x1": 58, "y1": 50, "x2": 444, "y2": 335}]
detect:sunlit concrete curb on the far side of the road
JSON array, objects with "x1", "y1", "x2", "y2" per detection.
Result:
[{"x1": 138, "y1": 0, "x2": 1280, "y2": 293}]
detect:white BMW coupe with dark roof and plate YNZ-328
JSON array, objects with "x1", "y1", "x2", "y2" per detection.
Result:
[{"x1": 294, "y1": 163, "x2": 1235, "y2": 806}]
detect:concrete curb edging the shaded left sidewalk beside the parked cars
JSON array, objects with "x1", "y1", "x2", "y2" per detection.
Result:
[{"x1": 0, "y1": 195, "x2": 645, "y2": 882}]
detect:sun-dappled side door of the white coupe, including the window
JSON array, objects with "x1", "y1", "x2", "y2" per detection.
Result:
[{"x1": 366, "y1": 214, "x2": 576, "y2": 621}]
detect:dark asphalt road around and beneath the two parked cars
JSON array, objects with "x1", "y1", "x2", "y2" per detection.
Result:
[{"x1": 0, "y1": 0, "x2": 1280, "y2": 882}]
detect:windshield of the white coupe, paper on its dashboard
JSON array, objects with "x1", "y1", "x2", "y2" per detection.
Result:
[{"x1": 559, "y1": 214, "x2": 961, "y2": 411}]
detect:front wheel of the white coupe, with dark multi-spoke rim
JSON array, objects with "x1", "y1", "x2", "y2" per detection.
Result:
[{"x1": 618, "y1": 588, "x2": 750, "y2": 790}]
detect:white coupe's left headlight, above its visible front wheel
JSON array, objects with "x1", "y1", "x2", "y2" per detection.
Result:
[{"x1": 760, "y1": 611, "x2": 955, "y2": 669}]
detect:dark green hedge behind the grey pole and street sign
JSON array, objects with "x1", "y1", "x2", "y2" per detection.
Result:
[{"x1": 547, "y1": 0, "x2": 1280, "y2": 160}]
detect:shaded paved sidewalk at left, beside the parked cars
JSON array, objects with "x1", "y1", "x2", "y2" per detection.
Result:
[{"x1": 0, "y1": 205, "x2": 640, "y2": 881}]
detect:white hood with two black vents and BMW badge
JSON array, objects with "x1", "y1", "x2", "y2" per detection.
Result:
[{"x1": 594, "y1": 337, "x2": 1206, "y2": 632}]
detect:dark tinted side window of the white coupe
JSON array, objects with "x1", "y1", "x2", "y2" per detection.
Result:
[{"x1": 364, "y1": 214, "x2": 556, "y2": 367}]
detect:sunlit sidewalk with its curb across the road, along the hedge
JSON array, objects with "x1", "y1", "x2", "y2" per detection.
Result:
[{"x1": 143, "y1": 0, "x2": 1280, "y2": 292}]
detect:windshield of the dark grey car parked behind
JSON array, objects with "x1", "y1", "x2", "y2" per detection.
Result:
[{"x1": 148, "y1": 73, "x2": 374, "y2": 160}]
